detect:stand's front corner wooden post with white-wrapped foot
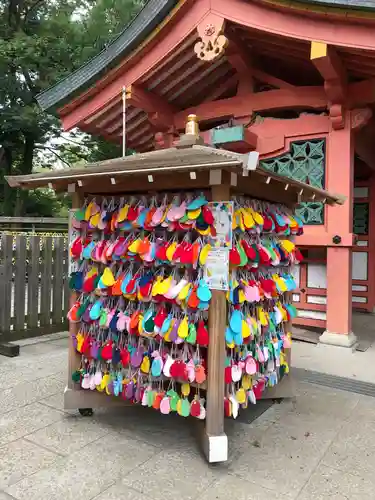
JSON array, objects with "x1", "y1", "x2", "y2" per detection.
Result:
[{"x1": 203, "y1": 175, "x2": 230, "y2": 462}]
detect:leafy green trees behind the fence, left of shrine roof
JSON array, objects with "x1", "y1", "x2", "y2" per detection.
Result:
[{"x1": 0, "y1": 0, "x2": 145, "y2": 215}]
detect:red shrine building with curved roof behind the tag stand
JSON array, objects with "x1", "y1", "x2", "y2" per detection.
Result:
[{"x1": 38, "y1": 0, "x2": 375, "y2": 347}]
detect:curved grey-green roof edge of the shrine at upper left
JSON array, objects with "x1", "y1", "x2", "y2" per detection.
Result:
[{"x1": 36, "y1": 0, "x2": 178, "y2": 112}]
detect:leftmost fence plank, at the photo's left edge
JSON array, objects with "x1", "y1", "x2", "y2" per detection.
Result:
[{"x1": 0, "y1": 234, "x2": 13, "y2": 333}]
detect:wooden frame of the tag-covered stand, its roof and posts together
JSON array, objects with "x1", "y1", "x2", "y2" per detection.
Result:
[{"x1": 8, "y1": 135, "x2": 343, "y2": 462}]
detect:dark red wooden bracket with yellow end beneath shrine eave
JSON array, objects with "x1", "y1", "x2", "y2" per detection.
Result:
[{"x1": 310, "y1": 42, "x2": 348, "y2": 130}]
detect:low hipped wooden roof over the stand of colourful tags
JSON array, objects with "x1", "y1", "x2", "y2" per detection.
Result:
[{"x1": 6, "y1": 140, "x2": 345, "y2": 205}]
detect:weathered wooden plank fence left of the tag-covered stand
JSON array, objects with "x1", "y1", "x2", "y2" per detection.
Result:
[{"x1": 0, "y1": 233, "x2": 69, "y2": 341}]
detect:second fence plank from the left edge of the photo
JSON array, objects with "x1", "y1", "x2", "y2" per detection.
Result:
[{"x1": 14, "y1": 235, "x2": 26, "y2": 331}]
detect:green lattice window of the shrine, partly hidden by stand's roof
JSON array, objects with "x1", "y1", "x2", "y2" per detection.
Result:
[{"x1": 261, "y1": 139, "x2": 325, "y2": 225}]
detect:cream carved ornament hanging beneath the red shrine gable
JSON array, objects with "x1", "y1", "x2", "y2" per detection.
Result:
[{"x1": 194, "y1": 14, "x2": 228, "y2": 62}]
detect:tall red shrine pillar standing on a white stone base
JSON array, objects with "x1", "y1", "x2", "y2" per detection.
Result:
[{"x1": 320, "y1": 112, "x2": 356, "y2": 347}]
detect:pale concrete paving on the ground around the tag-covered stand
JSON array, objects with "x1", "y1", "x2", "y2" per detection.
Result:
[{"x1": 0, "y1": 335, "x2": 375, "y2": 500}]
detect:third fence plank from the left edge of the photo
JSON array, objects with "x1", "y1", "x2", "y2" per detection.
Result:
[{"x1": 27, "y1": 236, "x2": 40, "y2": 328}]
